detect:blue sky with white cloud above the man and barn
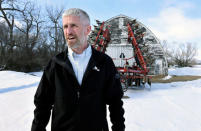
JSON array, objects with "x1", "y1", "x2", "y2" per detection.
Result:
[{"x1": 37, "y1": 0, "x2": 201, "y2": 59}]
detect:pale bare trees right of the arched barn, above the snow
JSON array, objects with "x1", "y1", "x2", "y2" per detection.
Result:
[{"x1": 162, "y1": 40, "x2": 197, "y2": 67}]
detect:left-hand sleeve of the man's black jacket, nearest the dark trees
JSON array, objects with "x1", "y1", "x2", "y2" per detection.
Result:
[{"x1": 31, "y1": 62, "x2": 54, "y2": 131}]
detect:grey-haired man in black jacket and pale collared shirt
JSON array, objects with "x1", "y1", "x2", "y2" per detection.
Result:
[{"x1": 31, "y1": 8, "x2": 125, "y2": 131}]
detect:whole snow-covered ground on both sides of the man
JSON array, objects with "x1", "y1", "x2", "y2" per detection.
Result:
[{"x1": 0, "y1": 66, "x2": 201, "y2": 131}]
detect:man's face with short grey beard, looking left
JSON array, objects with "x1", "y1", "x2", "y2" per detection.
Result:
[{"x1": 63, "y1": 15, "x2": 91, "y2": 48}]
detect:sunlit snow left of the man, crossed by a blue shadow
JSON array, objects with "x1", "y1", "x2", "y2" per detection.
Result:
[{"x1": 0, "y1": 71, "x2": 40, "y2": 131}]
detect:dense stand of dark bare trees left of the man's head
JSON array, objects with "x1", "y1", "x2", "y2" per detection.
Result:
[{"x1": 0, "y1": 0, "x2": 66, "y2": 72}]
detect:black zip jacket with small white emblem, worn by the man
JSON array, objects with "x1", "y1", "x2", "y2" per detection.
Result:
[{"x1": 31, "y1": 48, "x2": 125, "y2": 131}]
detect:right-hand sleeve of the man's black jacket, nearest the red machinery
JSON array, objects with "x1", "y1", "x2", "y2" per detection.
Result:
[{"x1": 106, "y1": 59, "x2": 125, "y2": 131}]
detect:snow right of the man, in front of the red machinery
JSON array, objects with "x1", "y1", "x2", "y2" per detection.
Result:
[{"x1": 124, "y1": 80, "x2": 201, "y2": 131}]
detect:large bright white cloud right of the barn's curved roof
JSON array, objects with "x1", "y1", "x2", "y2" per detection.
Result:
[{"x1": 148, "y1": 5, "x2": 201, "y2": 60}]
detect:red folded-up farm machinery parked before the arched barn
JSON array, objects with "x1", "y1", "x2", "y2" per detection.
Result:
[{"x1": 90, "y1": 20, "x2": 151, "y2": 91}]
